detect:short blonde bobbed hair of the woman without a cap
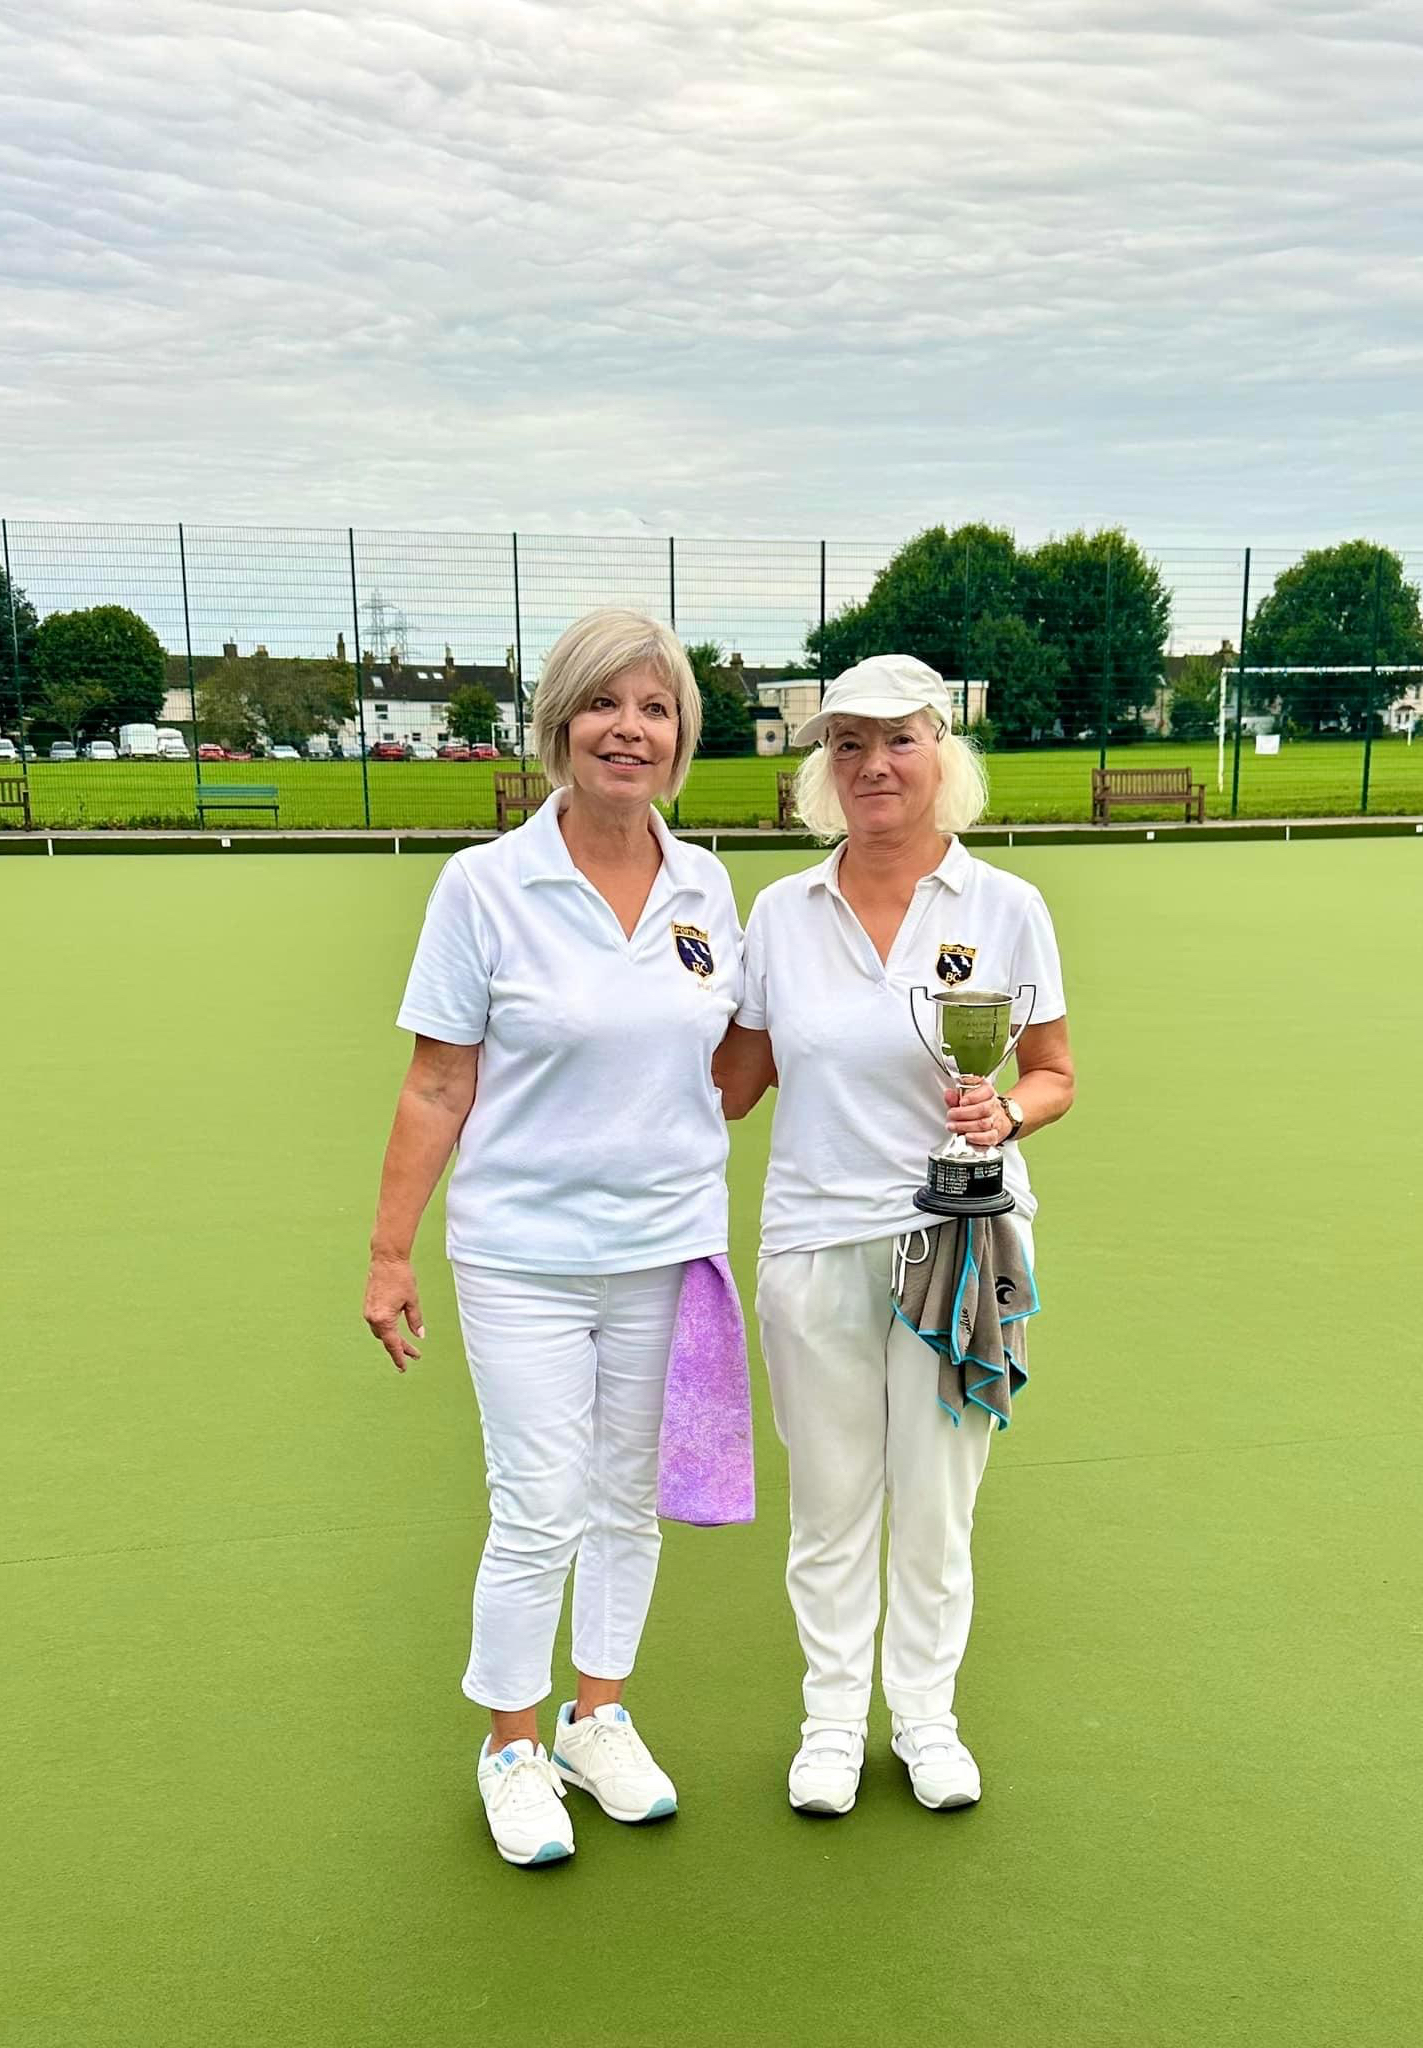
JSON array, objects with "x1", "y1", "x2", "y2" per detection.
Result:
[{"x1": 534, "y1": 604, "x2": 702, "y2": 797}]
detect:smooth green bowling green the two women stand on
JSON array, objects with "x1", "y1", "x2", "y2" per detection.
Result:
[{"x1": 0, "y1": 840, "x2": 1423, "y2": 2048}]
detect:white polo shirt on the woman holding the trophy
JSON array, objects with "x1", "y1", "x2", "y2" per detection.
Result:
[{"x1": 737, "y1": 840, "x2": 1067, "y2": 1253}]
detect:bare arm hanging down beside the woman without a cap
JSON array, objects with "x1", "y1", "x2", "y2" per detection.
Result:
[{"x1": 362, "y1": 1038, "x2": 479, "y2": 1372}]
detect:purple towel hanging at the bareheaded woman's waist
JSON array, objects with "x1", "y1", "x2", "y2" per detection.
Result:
[{"x1": 657, "y1": 1253, "x2": 756, "y2": 1528}]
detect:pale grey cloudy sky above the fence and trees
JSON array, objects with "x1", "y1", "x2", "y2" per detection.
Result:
[{"x1": 0, "y1": 0, "x2": 1423, "y2": 569}]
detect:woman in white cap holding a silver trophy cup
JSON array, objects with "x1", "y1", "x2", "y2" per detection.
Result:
[{"x1": 715, "y1": 655, "x2": 1073, "y2": 1812}]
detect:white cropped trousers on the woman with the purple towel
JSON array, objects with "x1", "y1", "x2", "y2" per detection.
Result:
[{"x1": 455, "y1": 1262, "x2": 682, "y2": 1712}]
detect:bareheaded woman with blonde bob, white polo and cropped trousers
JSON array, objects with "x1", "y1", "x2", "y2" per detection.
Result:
[{"x1": 364, "y1": 610, "x2": 741, "y2": 1864}]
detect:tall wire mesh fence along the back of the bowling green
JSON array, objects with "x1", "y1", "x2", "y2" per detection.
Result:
[{"x1": 0, "y1": 520, "x2": 1423, "y2": 831}]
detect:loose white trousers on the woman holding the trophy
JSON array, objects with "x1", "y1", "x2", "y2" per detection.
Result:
[{"x1": 756, "y1": 1221, "x2": 1032, "y2": 1726}]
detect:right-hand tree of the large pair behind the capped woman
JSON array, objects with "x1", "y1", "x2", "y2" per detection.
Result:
[{"x1": 1024, "y1": 526, "x2": 1171, "y2": 739}]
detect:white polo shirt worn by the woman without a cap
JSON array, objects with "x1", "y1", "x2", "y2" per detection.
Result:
[{"x1": 399, "y1": 791, "x2": 741, "y2": 1274}]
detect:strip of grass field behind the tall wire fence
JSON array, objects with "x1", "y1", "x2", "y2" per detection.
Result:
[{"x1": 11, "y1": 739, "x2": 1423, "y2": 829}]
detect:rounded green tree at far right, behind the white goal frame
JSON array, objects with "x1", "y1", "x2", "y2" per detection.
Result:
[{"x1": 1245, "y1": 541, "x2": 1423, "y2": 731}]
